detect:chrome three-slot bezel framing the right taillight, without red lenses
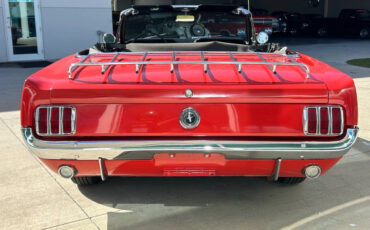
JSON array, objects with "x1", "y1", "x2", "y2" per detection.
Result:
[{"x1": 303, "y1": 106, "x2": 344, "y2": 136}]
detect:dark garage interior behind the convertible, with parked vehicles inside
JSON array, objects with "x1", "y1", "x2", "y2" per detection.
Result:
[{"x1": 112, "y1": 0, "x2": 370, "y2": 39}]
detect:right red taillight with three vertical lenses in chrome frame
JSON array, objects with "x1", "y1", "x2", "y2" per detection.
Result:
[{"x1": 303, "y1": 106, "x2": 344, "y2": 136}]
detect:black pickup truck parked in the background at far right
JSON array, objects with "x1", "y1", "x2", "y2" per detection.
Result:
[{"x1": 316, "y1": 9, "x2": 370, "y2": 39}]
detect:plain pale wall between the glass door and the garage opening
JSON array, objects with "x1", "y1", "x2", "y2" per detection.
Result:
[{"x1": 41, "y1": 0, "x2": 112, "y2": 59}]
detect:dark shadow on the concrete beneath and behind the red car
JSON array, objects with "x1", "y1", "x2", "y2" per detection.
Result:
[{"x1": 79, "y1": 139, "x2": 370, "y2": 230}]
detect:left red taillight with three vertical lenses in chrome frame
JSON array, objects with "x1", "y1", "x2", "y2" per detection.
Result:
[{"x1": 35, "y1": 106, "x2": 76, "y2": 136}]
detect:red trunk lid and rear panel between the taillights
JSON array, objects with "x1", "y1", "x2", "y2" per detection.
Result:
[{"x1": 51, "y1": 52, "x2": 328, "y2": 137}]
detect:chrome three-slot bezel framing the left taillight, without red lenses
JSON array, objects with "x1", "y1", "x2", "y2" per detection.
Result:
[{"x1": 35, "y1": 105, "x2": 77, "y2": 136}]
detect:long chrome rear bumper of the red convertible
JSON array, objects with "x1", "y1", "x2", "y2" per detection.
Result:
[{"x1": 22, "y1": 127, "x2": 358, "y2": 160}]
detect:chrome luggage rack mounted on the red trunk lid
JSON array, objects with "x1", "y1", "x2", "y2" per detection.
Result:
[{"x1": 68, "y1": 51, "x2": 310, "y2": 80}]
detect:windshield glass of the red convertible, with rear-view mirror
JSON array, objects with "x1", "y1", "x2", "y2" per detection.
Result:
[{"x1": 125, "y1": 12, "x2": 246, "y2": 43}]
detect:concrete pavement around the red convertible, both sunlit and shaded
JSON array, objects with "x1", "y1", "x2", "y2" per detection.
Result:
[{"x1": 0, "y1": 39, "x2": 370, "y2": 230}]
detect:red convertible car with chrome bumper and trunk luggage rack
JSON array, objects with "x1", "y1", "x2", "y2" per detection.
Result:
[{"x1": 21, "y1": 5, "x2": 358, "y2": 185}]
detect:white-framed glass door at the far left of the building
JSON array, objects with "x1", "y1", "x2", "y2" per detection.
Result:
[{"x1": 3, "y1": 0, "x2": 44, "y2": 61}]
